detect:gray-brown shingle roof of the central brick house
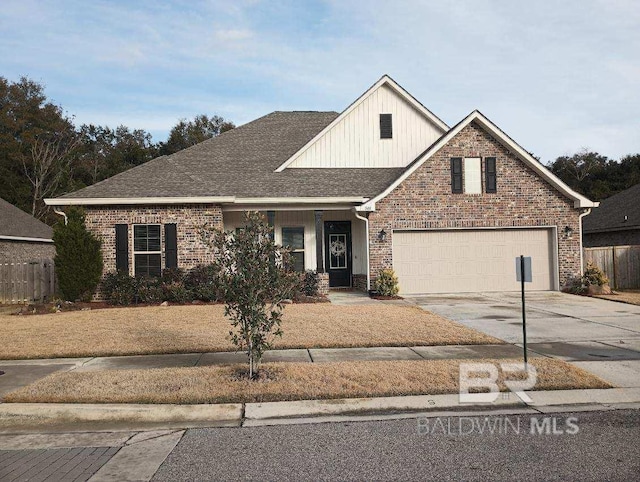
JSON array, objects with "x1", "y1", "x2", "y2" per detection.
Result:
[{"x1": 62, "y1": 112, "x2": 403, "y2": 198}]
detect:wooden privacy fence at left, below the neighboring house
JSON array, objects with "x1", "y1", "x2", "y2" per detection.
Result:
[{"x1": 0, "y1": 259, "x2": 56, "y2": 303}]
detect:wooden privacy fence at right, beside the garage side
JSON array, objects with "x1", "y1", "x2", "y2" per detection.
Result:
[{"x1": 584, "y1": 246, "x2": 640, "y2": 290}]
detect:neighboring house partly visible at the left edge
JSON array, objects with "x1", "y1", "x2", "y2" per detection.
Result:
[{"x1": 0, "y1": 199, "x2": 56, "y2": 262}]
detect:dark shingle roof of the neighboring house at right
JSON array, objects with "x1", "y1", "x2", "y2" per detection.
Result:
[{"x1": 582, "y1": 183, "x2": 640, "y2": 233}]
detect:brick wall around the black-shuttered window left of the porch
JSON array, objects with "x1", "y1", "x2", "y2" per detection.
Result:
[{"x1": 85, "y1": 204, "x2": 222, "y2": 275}]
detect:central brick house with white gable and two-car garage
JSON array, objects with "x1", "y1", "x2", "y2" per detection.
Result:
[{"x1": 46, "y1": 75, "x2": 596, "y2": 294}]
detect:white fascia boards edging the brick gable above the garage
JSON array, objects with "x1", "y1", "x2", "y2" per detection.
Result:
[{"x1": 358, "y1": 110, "x2": 599, "y2": 211}]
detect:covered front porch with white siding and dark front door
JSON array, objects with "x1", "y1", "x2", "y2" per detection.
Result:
[{"x1": 223, "y1": 208, "x2": 368, "y2": 292}]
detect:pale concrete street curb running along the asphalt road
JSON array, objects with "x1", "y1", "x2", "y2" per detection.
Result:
[{"x1": 0, "y1": 388, "x2": 640, "y2": 433}]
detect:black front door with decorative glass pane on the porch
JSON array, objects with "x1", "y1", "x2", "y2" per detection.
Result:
[{"x1": 324, "y1": 221, "x2": 351, "y2": 288}]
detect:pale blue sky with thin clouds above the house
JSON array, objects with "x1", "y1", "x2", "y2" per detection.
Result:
[{"x1": 0, "y1": 0, "x2": 640, "y2": 162}]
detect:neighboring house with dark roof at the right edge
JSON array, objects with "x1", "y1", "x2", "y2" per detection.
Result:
[{"x1": 582, "y1": 184, "x2": 640, "y2": 248}]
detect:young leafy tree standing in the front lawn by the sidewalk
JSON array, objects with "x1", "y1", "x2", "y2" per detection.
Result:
[{"x1": 203, "y1": 212, "x2": 299, "y2": 379}]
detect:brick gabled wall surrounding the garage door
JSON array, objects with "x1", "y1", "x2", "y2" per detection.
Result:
[{"x1": 369, "y1": 123, "x2": 580, "y2": 286}]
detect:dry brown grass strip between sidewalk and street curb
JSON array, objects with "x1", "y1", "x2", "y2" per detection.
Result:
[{"x1": 5, "y1": 358, "x2": 611, "y2": 403}]
